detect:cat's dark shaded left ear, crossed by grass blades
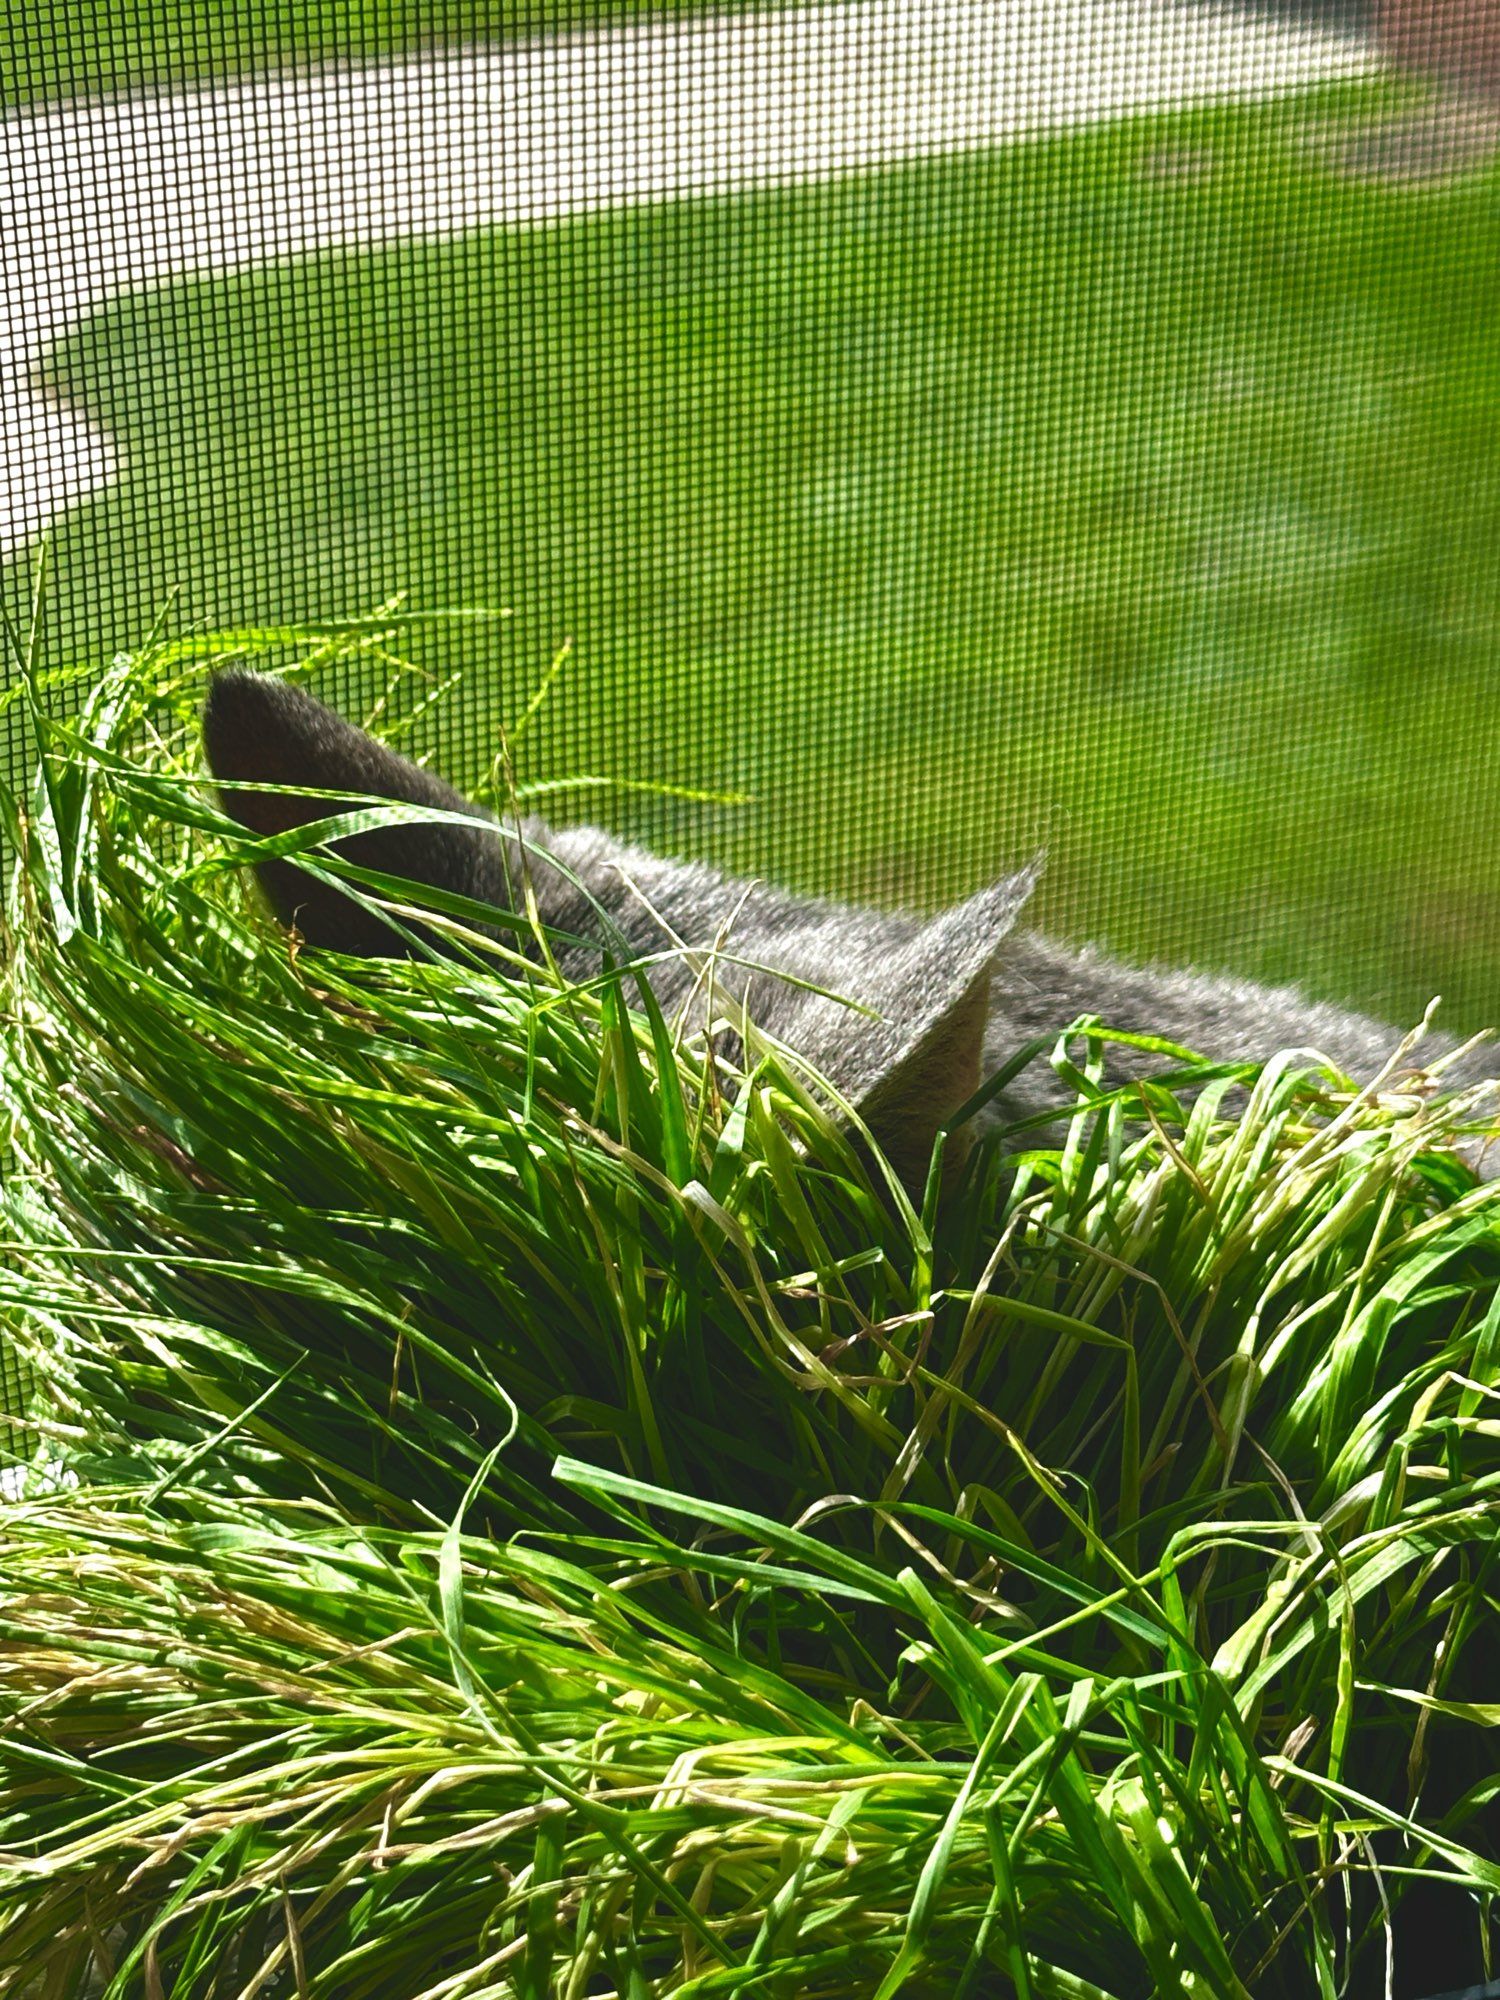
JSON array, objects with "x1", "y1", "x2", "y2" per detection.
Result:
[{"x1": 204, "y1": 670, "x2": 508, "y2": 958}]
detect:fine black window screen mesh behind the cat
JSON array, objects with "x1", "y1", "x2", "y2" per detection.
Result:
[{"x1": 0, "y1": 0, "x2": 1500, "y2": 1416}]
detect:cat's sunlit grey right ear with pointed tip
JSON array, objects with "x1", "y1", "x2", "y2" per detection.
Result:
[{"x1": 792, "y1": 868, "x2": 1036, "y2": 1192}]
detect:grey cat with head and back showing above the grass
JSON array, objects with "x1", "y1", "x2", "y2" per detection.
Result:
[{"x1": 204, "y1": 672, "x2": 1500, "y2": 1180}]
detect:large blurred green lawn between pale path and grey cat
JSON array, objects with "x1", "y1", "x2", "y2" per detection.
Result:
[{"x1": 10, "y1": 84, "x2": 1500, "y2": 1026}]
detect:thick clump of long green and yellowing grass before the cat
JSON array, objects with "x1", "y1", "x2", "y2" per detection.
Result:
[{"x1": 0, "y1": 632, "x2": 1500, "y2": 2000}]
